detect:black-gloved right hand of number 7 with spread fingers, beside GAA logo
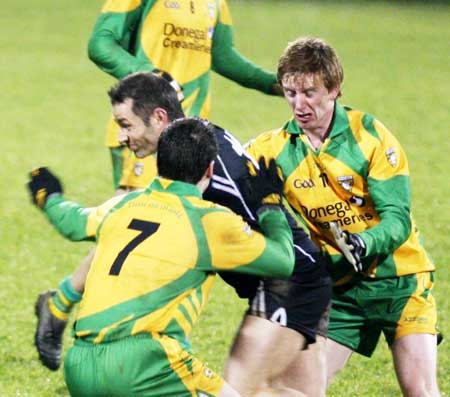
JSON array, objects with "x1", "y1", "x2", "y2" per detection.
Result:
[{"x1": 243, "y1": 157, "x2": 283, "y2": 210}]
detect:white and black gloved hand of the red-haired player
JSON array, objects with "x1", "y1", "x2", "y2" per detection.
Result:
[{"x1": 330, "y1": 222, "x2": 366, "y2": 272}]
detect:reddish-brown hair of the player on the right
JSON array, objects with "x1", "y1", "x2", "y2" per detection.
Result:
[{"x1": 277, "y1": 37, "x2": 344, "y2": 90}]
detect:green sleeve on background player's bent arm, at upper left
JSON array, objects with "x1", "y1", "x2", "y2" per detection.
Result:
[{"x1": 88, "y1": 5, "x2": 155, "y2": 79}]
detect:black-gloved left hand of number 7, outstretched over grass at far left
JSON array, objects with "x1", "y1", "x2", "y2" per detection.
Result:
[{"x1": 27, "y1": 167, "x2": 63, "y2": 209}]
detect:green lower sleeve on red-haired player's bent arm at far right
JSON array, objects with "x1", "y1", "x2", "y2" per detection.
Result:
[{"x1": 359, "y1": 175, "x2": 411, "y2": 256}]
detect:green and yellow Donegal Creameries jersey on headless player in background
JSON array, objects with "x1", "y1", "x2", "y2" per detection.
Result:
[{"x1": 88, "y1": 0, "x2": 276, "y2": 118}]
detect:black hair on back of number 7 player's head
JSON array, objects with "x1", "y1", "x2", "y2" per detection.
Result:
[{"x1": 156, "y1": 118, "x2": 218, "y2": 184}]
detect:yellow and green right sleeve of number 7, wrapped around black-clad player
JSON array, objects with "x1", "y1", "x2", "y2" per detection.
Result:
[{"x1": 200, "y1": 206, "x2": 294, "y2": 277}]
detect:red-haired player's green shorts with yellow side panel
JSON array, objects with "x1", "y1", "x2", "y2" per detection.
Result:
[{"x1": 328, "y1": 272, "x2": 437, "y2": 357}]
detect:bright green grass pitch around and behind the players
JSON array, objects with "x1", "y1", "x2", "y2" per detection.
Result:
[{"x1": 0, "y1": 0, "x2": 450, "y2": 397}]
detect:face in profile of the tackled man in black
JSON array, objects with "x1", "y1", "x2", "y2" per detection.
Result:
[{"x1": 113, "y1": 98, "x2": 162, "y2": 158}]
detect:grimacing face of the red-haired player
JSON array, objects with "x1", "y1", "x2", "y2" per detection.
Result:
[{"x1": 282, "y1": 74, "x2": 340, "y2": 133}]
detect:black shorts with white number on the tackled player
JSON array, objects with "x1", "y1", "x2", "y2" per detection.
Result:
[{"x1": 247, "y1": 278, "x2": 331, "y2": 347}]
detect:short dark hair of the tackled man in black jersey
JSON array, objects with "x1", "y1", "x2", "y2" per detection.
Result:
[{"x1": 108, "y1": 72, "x2": 184, "y2": 126}]
